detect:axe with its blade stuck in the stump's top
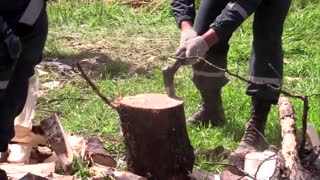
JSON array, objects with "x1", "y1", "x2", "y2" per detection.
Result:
[{"x1": 162, "y1": 53, "x2": 186, "y2": 99}]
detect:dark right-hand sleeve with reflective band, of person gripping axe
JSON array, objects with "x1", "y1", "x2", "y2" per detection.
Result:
[{"x1": 210, "y1": 0, "x2": 262, "y2": 39}]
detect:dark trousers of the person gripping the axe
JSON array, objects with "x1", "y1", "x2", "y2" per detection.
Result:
[{"x1": 193, "y1": 0, "x2": 291, "y2": 103}]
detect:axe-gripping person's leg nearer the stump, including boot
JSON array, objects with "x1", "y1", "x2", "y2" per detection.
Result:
[{"x1": 188, "y1": 0, "x2": 230, "y2": 126}]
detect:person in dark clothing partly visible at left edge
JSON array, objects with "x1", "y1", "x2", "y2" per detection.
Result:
[{"x1": 0, "y1": 0, "x2": 48, "y2": 162}]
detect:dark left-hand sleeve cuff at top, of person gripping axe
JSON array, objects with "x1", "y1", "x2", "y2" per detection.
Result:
[{"x1": 171, "y1": 0, "x2": 196, "y2": 26}]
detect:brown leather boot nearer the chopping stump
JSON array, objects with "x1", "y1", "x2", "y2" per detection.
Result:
[{"x1": 187, "y1": 89, "x2": 225, "y2": 127}]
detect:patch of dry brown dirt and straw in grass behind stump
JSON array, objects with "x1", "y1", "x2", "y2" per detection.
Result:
[{"x1": 44, "y1": 35, "x2": 173, "y2": 77}]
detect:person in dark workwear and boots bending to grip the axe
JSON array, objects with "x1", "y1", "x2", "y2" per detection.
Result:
[{"x1": 171, "y1": 0, "x2": 291, "y2": 153}]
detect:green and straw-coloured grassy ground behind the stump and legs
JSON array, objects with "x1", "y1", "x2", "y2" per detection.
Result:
[{"x1": 37, "y1": 0, "x2": 320, "y2": 177}]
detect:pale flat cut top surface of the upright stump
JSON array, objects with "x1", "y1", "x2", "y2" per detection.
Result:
[{"x1": 120, "y1": 94, "x2": 183, "y2": 110}]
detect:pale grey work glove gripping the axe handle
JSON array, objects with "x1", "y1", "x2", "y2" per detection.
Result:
[{"x1": 175, "y1": 36, "x2": 209, "y2": 65}]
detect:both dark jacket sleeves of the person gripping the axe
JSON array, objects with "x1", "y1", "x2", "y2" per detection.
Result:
[{"x1": 171, "y1": 0, "x2": 262, "y2": 39}]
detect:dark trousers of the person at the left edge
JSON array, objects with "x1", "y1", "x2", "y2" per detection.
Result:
[{"x1": 0, "y1": 8, "x2": 48, "y2": 152}]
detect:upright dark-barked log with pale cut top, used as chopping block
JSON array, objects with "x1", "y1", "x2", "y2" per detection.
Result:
[{"x1": 117, "y1": 94, "x2": 195, "y2": 180}]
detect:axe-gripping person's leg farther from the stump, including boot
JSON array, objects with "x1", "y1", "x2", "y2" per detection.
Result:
[{"x1": 238, "y1": 0, "x2": 291, "y2": 151}]
